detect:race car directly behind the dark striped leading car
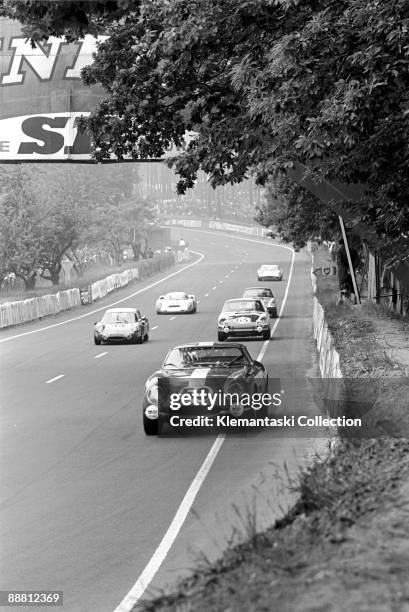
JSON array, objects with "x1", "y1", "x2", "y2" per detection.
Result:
[{"x1": 217, "y1": 298, "x2": 271, "y2": 341}]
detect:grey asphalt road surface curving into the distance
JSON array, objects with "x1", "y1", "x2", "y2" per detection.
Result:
[{"x1": 0, "y1": 229, "x2": 322, "y2": 612}]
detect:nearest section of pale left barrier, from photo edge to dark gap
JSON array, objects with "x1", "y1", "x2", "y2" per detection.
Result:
[{"x1": 0, "y1": 288, "x2": 81, "y2": 328}]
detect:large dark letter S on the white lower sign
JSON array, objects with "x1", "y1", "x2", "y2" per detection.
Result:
[{"x1": 18, "y1": 117, "x2": 68, "y2": 155}]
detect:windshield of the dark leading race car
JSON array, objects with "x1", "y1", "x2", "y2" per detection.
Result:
[{"x1": 163, "y1": 346, "x2": 249, "y2": 368}]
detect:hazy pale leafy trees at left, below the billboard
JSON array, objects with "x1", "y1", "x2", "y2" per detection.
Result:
[{"x1": 0, "y1": 164, "x2": 153, "y2": 289}]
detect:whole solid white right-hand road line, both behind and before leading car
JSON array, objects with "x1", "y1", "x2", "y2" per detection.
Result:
[{"x1": 114, "y1": 236, "x2": 295, "y2": 612}]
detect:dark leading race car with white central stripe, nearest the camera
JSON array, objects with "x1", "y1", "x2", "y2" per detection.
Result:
[{"x1": 142, "y1": 342, "x2": 268, "y2": 436}]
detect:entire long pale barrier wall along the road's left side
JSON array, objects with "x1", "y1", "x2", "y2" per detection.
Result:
[{"x1": 0, "y1": 253, "x2": 175, "y2": 328}]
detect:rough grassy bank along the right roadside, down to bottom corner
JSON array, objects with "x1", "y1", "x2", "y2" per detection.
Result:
[{"x1": 135, "y1": 260, "x2": 409, "y2": 612}]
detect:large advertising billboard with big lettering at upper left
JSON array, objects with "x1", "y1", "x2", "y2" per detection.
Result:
[{"x1": 0, "y1": 18, "x2": 107, "y2": 162}]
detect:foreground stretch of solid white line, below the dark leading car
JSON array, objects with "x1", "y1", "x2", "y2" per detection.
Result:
[{"x1": 115, "y1": 435, "x2": 225, "y2": 612}]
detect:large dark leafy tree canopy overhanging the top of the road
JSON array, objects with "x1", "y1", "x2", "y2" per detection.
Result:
[{"x1": 8, "y1": 0, "x2": 409, "y2": 257}]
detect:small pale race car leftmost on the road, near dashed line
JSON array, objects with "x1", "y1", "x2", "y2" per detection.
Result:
[{"x1": 94, "y1": 308, "x2": 149, "y2": 344}]
